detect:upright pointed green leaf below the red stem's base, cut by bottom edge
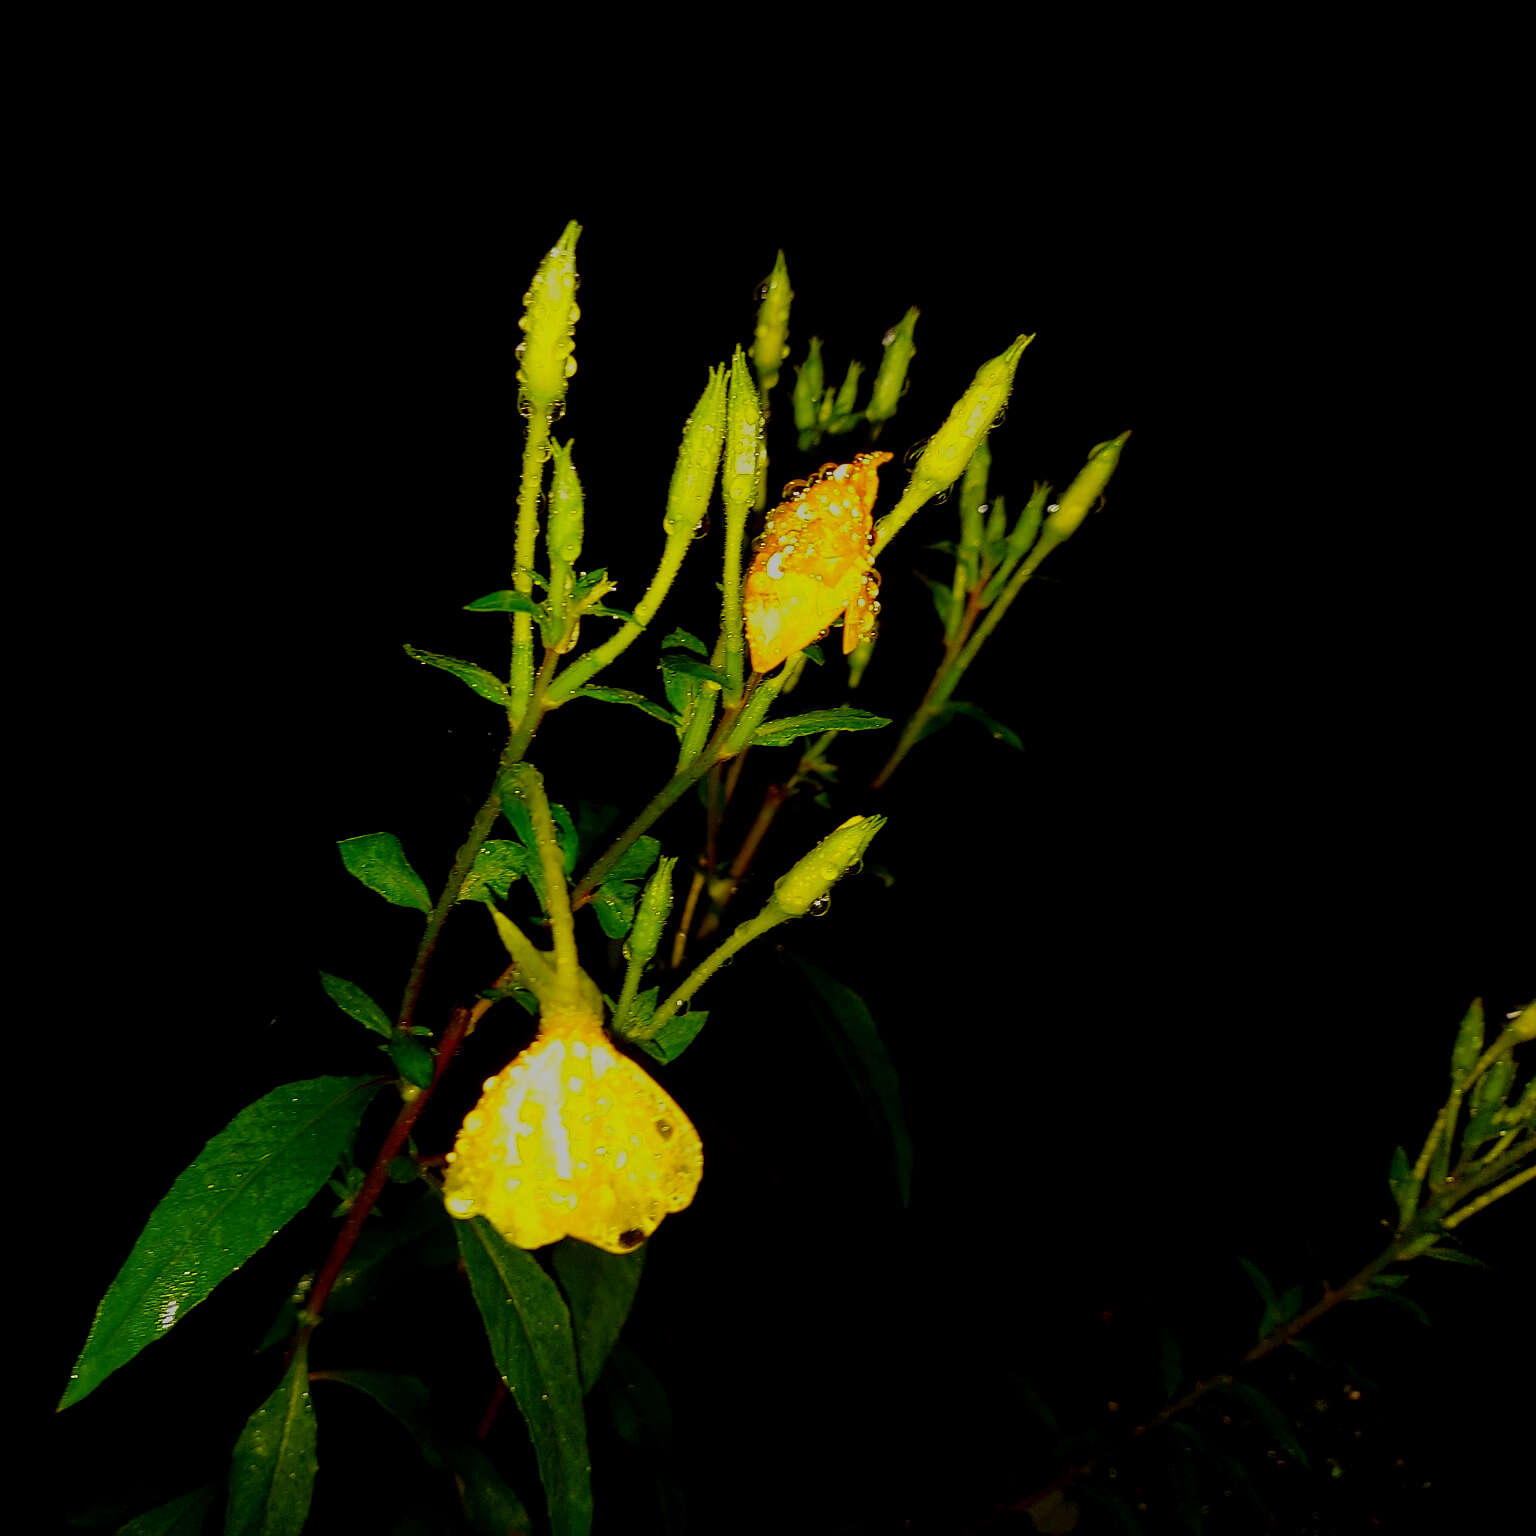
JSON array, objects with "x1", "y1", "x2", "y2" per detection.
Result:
[{"x1": 224, "y1": 1344, "x2": 319, "y2": 1536}]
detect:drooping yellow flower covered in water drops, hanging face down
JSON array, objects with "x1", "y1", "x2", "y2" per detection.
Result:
[{"x1": 442, "y1": 1012, "x2": 703, "y2": 1253}]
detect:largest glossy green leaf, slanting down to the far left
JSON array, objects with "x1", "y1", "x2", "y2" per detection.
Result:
[{"x1": 58, "y1": 1077, "x2": 376, "y2": 1409}]
